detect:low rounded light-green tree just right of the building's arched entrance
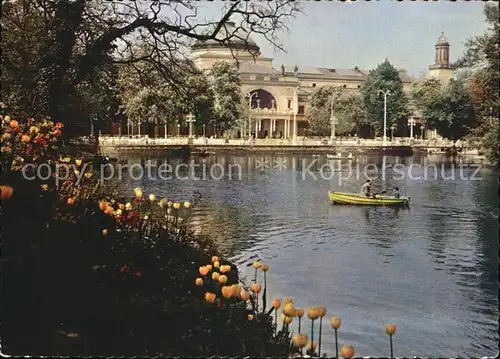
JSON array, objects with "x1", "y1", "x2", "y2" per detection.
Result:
[{"x1": 306, "y1": 86, "x2": 368, "y2": 134}]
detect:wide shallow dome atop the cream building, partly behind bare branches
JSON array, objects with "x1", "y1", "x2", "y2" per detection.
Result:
[{"x1": 191, "y1": 21, "x2": 260, "y2": 54}]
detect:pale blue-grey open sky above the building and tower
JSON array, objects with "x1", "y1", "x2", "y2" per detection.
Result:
[{"x1": 193, "y1": 0, "x2": 487, "y2": 77}]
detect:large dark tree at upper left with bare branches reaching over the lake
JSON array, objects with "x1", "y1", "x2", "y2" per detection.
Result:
[{"x1": 1, "y1": 0, "x2": 301, "y2": 134}]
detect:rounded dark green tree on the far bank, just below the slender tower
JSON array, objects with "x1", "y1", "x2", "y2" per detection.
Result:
[{"x1": 416, "y1": 80, "x2": 476, "y2": 140}]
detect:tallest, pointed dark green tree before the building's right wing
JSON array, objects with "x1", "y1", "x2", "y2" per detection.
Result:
[{"x1": 361, "y1": 60, "x2": 409, "y2": 136}]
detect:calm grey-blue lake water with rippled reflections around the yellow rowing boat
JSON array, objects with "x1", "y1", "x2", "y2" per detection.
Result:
[{"x1": 110, "y1": 155, "x2": 499, "y2": 357}]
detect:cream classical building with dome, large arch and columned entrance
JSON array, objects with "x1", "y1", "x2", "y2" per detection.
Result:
[{"x1": 192, "y1": 22, "x2": 412, "y2": 138}]
